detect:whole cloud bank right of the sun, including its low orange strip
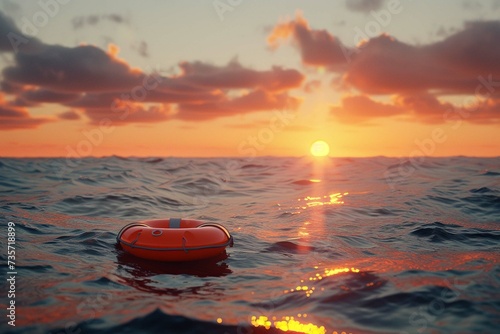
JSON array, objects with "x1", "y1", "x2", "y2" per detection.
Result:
[{"x1": 268, "y1": 11, "x2": 500, "y2": 124}]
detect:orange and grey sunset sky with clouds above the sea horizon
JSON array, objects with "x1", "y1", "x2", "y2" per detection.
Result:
[{"x1": 0, "y1": 0, "x2": 500, "y2": 157}]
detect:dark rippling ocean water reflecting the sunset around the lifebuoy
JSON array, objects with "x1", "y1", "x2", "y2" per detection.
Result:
[{"x1": 0, "y1": 157, "x2": 500, "y2": 334}]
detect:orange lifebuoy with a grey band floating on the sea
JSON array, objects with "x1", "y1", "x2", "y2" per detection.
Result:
[{"x1": 116, "y1": 218, "x2": 233, "y2": 261}]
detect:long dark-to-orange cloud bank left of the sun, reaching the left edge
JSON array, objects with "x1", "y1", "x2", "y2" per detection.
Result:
[{"x1": 0, "y1": 13, "x2": 304, "y2": 130}]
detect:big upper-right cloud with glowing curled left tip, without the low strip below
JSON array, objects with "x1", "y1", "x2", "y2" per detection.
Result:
[{"x1": 268, "y1": 14, "x2": 500, "y2": 94}]
